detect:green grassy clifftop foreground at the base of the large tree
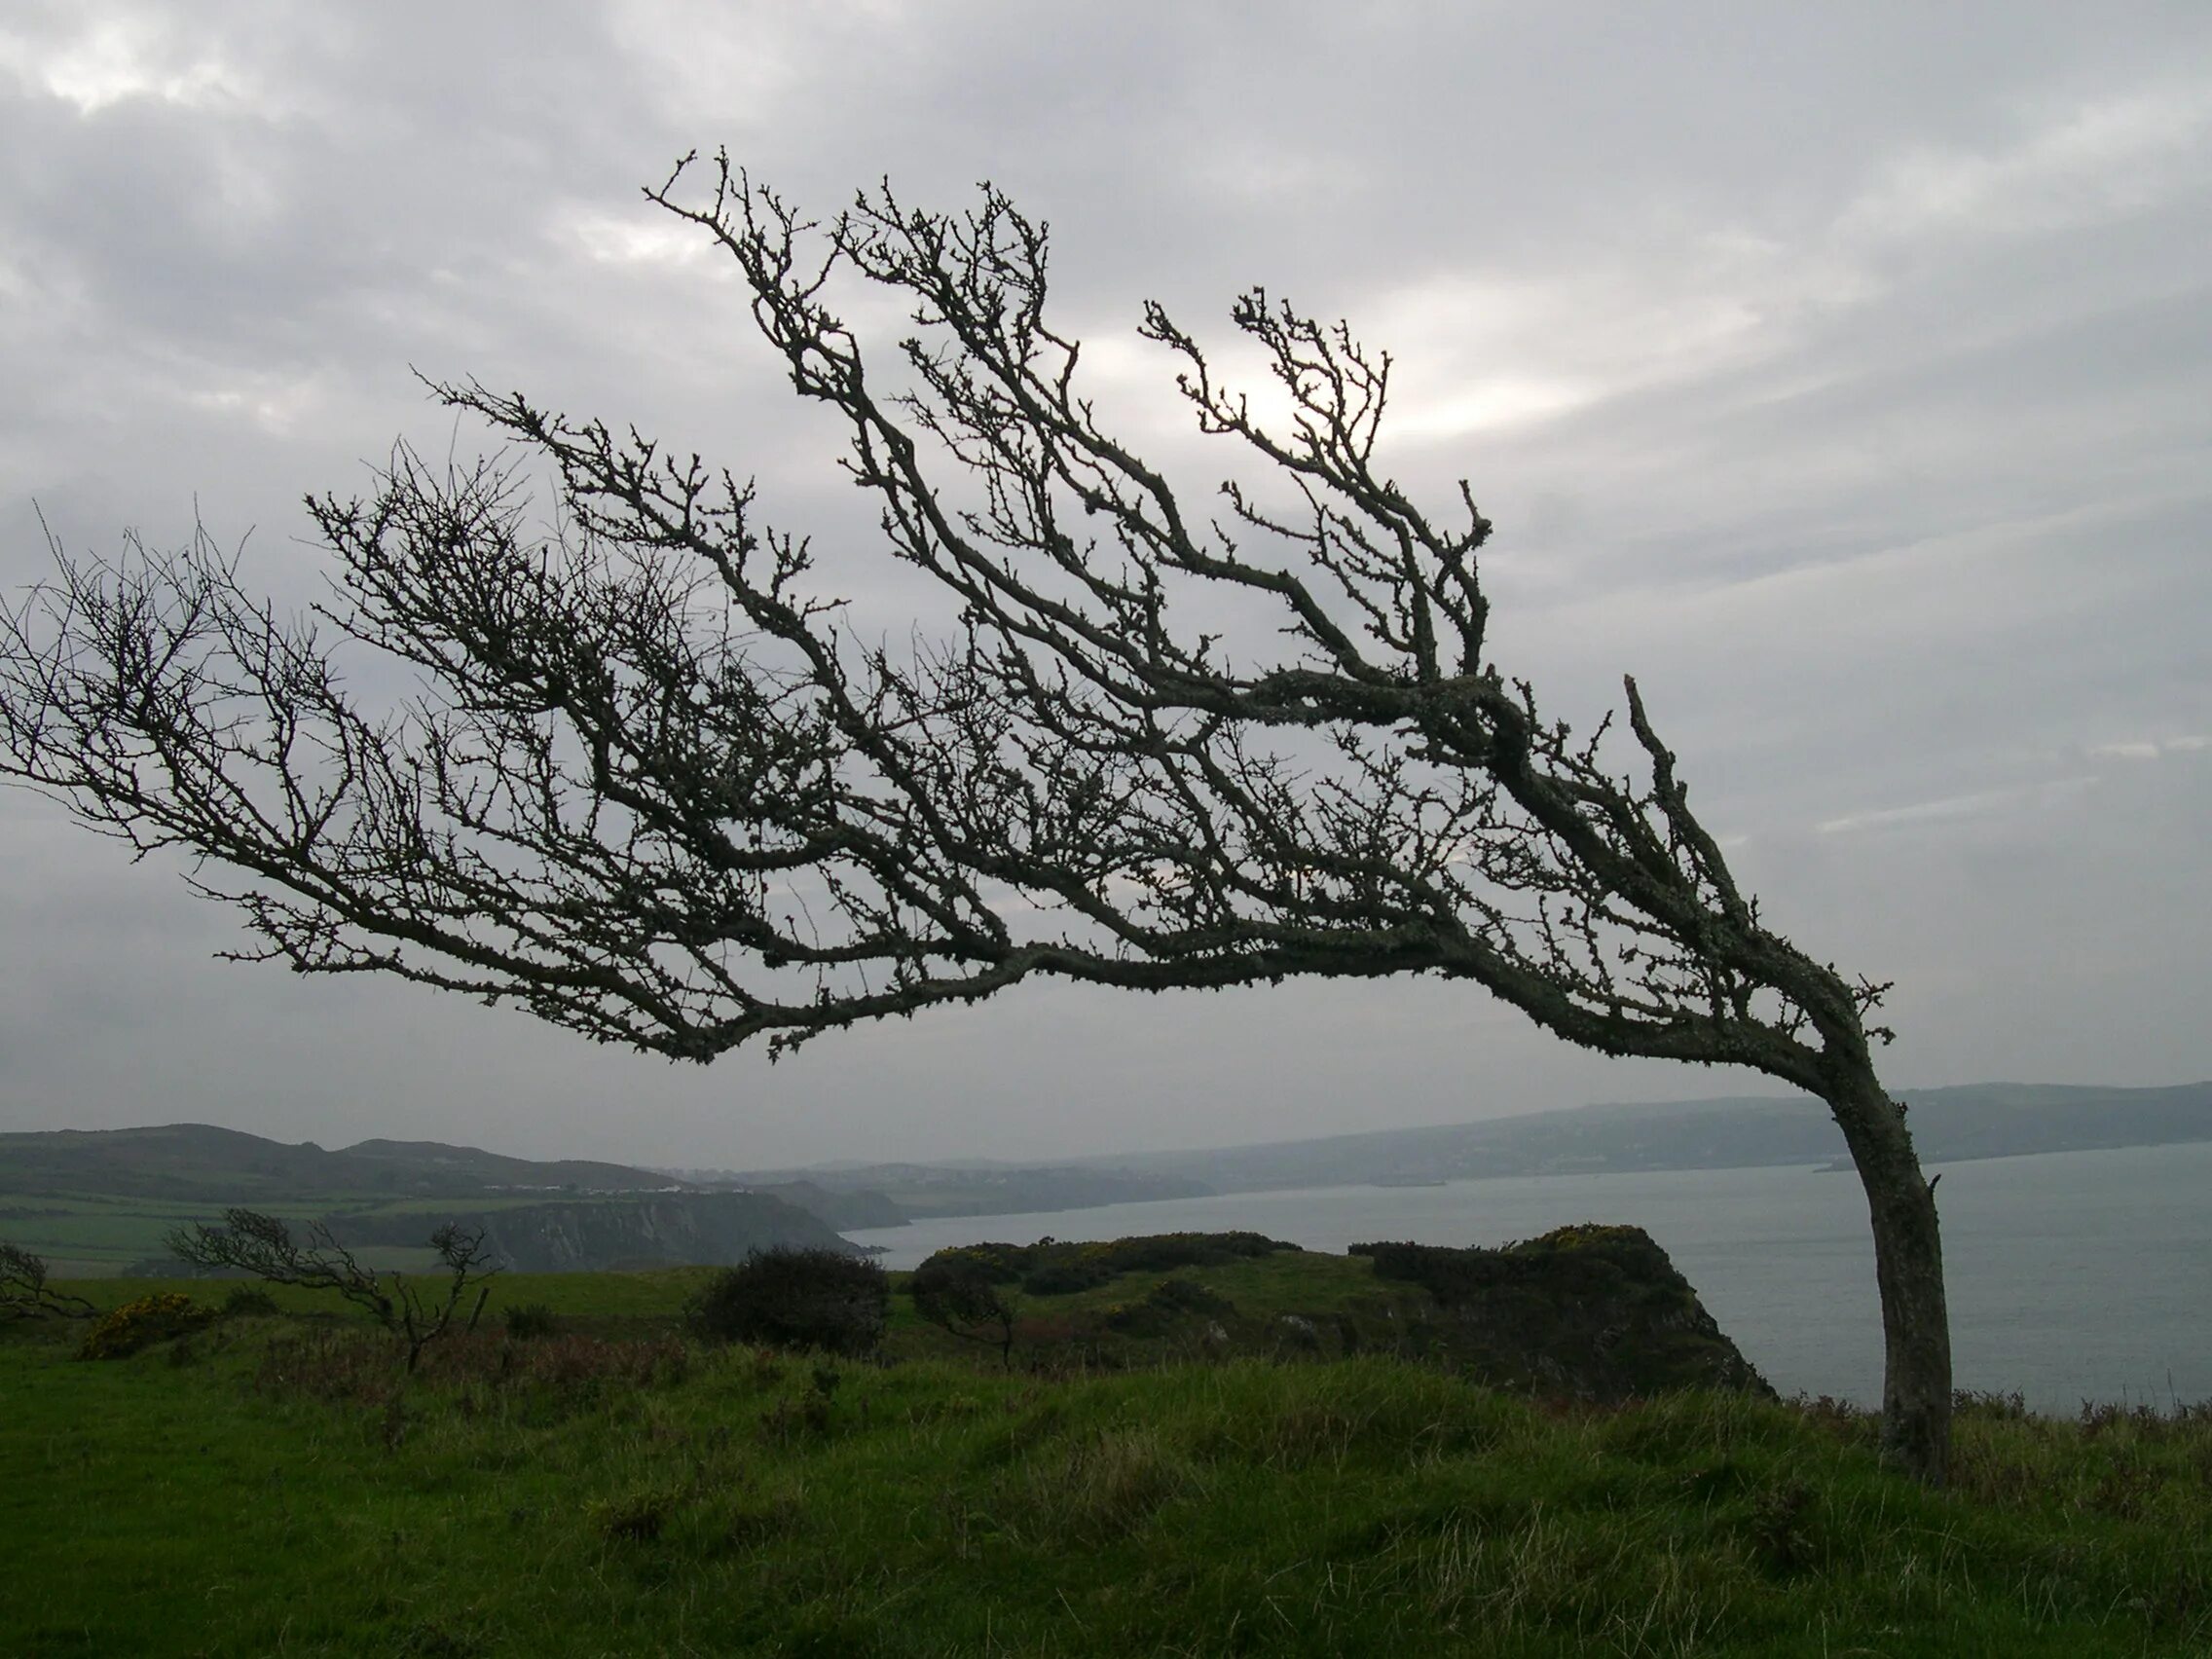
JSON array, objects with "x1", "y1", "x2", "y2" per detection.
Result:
[{"x1": 0, "y1": 1291, "x2": 2212, "y2": 1659}]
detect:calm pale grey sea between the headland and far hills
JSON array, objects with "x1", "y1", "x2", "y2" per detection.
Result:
[{"x1": 847, "y1": 1144, "x2": 2212, "y2": 1412}]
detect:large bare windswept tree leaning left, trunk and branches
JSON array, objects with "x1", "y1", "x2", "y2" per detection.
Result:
[{"x1": 0, "y1": 160, "x2": 1951, "y2": 1480}]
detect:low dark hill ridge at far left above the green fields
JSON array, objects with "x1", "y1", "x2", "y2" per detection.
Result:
[{"x1": 0, "y1": 1124, "x2": 682, "y2": 1203}]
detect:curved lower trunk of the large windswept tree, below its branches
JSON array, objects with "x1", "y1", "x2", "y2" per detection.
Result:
[{"x1": 1827, "y1": 1066, "x2": 1951, "y2": 1487}]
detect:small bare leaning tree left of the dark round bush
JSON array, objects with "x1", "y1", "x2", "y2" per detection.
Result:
[{"x1": 168, "y1": 1208, "x2": 499, "y2": 1372}]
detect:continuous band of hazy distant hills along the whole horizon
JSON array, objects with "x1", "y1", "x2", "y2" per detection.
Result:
[{"x1": 13, "y1": 1082, "x2": 2212, "y2": 1228}]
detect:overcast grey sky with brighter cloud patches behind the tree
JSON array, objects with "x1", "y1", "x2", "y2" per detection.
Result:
[{"x1": 0, "y1": 0, "x2": 2212, "y2": 1165}]
